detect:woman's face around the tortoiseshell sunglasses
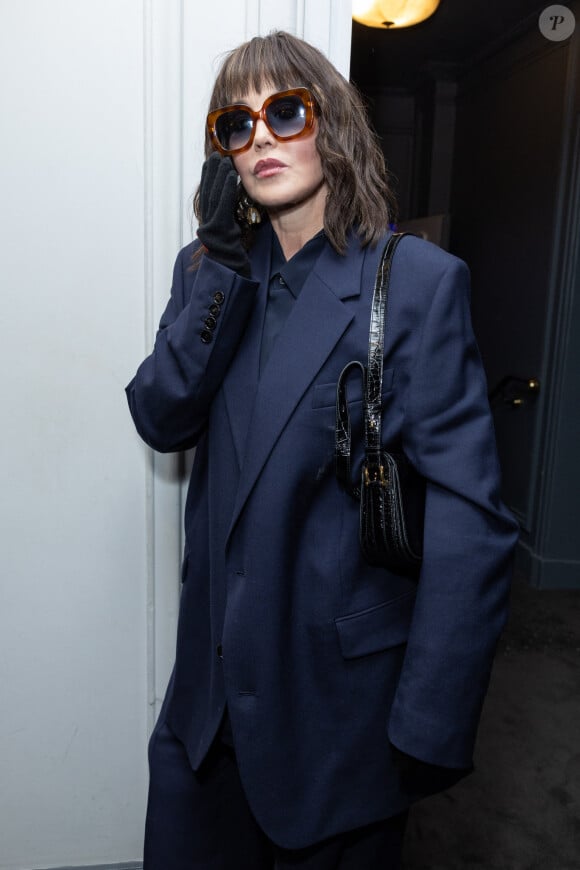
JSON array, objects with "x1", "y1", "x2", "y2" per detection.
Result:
[{"x1": 232, "y1": 88, "x2": 328, "y2": 226}]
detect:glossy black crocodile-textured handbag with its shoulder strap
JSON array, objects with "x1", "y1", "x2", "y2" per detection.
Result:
[{"x1": 335, "y1": 233, "x2": 425, "y2": 578}]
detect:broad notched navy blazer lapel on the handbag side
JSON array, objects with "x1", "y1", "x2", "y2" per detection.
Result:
[{"x1": 229, "y1": 233, "x2": 364, "y2": 535}]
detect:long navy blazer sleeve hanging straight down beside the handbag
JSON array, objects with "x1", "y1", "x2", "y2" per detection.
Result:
[{"x1": 388, "y1": 257, "x2": 518, "y2": 768}]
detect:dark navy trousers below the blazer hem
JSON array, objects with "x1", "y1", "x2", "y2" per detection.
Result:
[{"x1": 143, "y1": 723, "x2": 407, "y2": 870}]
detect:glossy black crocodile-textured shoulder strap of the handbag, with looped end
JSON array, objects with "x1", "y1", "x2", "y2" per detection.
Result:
[{"x1": 335, "y1": 233, "x2": 408, "y2": 498}]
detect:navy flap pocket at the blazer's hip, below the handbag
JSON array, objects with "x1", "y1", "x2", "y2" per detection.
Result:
[{"x1": 334, "y1": 592, "x2": 415, "y2": 659}]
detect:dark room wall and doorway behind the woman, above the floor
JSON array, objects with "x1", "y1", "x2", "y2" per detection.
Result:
[{"x1": 351, "y1": 0, "x2": 580, "y2": 588}]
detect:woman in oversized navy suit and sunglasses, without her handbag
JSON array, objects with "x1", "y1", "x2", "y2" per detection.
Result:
[{"x1": 127, "y1": 33, "x2": 516, "y2": 870}]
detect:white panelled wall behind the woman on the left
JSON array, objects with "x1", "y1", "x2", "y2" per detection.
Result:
[{"x1": 0, "y1": 0, "x2": 350, "y2": 870}]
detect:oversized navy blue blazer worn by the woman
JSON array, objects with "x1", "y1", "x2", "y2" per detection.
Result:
[{"x1": 127, "y1": 224, "x2": 517, "y2": 848}]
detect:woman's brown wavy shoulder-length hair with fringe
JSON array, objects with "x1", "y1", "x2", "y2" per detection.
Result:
[{"x1": 194, "y1": 31, "x2": 396, "y2": 254}]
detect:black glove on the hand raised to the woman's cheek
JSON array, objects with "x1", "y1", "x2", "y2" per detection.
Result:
[{"x1": 197, "y1": 151, "x2": 250, "y2": 277}]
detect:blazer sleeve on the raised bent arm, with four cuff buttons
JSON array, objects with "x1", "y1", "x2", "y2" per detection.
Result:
[{"x1": 126, "y1": 243, "x2": 259, "y2": 453}]
